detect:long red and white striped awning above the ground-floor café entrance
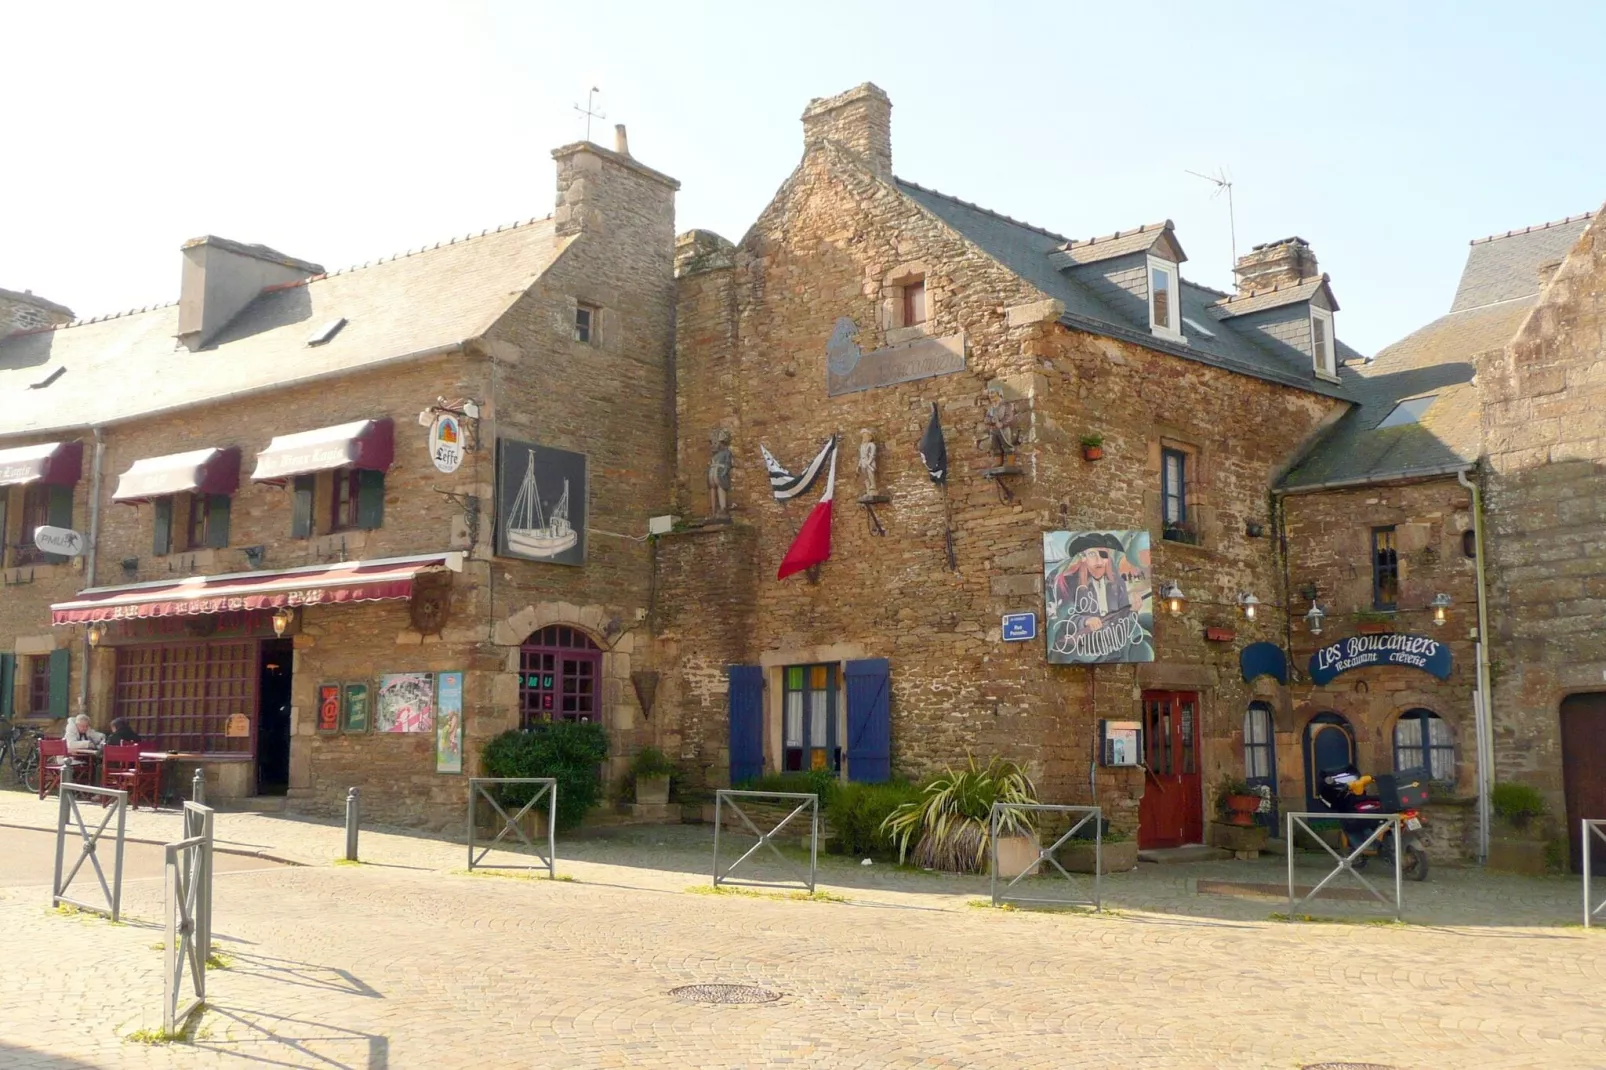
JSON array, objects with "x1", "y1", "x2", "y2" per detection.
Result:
[{"x1": 50, "y1": 553, "x2": 463, "y2": 625}]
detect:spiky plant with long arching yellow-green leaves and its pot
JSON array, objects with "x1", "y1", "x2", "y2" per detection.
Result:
[{"x1": 882, "y1": 758, "x2": 1039, "y2": 879}]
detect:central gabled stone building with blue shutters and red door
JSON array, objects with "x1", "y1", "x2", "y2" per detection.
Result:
[{"x1": 655, "y1": 85, "x2": 1359, "y2": 845}]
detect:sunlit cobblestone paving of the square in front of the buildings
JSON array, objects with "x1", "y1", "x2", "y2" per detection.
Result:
[{"x1": 0, "y1": 792, "x2": 1606, "y2": 1070}]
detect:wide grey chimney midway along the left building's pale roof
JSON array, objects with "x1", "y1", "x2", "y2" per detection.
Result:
[{"x1": 178, "y1": 235, "x2": 323, "y2": 350}]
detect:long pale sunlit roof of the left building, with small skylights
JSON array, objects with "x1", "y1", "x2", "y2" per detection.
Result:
[{"x1": 0, "y1": 218, "x2": 570, "y2": 435}]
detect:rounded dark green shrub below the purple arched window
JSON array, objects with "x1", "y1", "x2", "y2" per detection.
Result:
[{"x1": 482, "y1": 721, "x2": 607, "y2": 829}]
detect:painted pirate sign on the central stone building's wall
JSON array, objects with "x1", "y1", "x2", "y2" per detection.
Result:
[{"x1": 1042, "y1": 532, "x2": 1155, "y2": 665}]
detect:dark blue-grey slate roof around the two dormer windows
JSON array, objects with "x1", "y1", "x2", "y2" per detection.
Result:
[{"x1": 896, "y1": 178, "x2": 1355, "y2": 398}]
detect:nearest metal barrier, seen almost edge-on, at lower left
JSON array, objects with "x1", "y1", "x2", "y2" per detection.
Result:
[{"x1": 162, "y1": 802, "x2": 212, "y2": 1035}]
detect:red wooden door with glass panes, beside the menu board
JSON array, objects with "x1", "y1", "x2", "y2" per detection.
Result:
[{"x1": 1137, "y1": 691, "x2": 1205, "y2": 847}]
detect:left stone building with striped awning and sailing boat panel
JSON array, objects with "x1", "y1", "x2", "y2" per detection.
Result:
[{"x1": 0, "y1": 129, "x2": 678, "y2": 824}]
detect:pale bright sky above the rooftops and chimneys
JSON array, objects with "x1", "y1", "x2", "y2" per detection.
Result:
[{"x1": 0, "y1": 0, "x2": 1606, "y2": 353}]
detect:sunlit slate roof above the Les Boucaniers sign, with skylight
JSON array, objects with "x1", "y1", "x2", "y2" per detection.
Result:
[{"x1": 1283, "y1": 215, "x2": 1590, "y2": 490}]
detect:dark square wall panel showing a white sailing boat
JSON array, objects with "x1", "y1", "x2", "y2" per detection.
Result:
[{"x1": 496, "y1": 439, "x2": 586, "y2": 566}]
